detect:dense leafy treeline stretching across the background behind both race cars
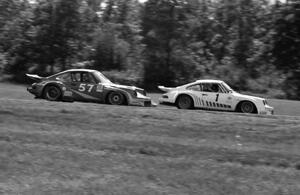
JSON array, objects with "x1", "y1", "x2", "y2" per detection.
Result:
[{"x1": 0, "y1": 0, "x2": 300, "y2": 99}]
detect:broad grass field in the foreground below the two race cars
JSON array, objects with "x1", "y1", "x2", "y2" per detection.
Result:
[{"x1": 0, "y1": 84, "x2": 300, "y2": 195}]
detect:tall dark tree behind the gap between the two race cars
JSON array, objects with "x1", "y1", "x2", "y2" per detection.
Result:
[{"x1": 142, "y1": 0, "x2": 195, "y2": 88}]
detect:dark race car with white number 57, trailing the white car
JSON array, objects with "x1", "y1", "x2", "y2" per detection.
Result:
[{"x1": 26, "y1": 69, "x2": 153, "y2": 106}]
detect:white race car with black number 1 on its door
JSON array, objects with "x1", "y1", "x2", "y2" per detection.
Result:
[{"x1": 158, "y1": 80, "x2": 274, "y2": 115}]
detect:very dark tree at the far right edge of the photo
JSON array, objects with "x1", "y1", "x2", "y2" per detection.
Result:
[{"x1": 273, "y1": 1, "x2": 300, "y2": 99}]
